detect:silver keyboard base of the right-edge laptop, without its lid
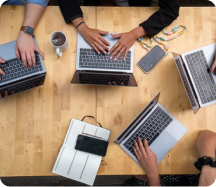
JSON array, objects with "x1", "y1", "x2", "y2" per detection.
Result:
[{"x1": 181, "y1": 43, "x2": 216, "y2": 107}]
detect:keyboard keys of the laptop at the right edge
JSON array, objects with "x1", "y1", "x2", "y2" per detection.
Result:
[{"x1": 185, "y1": 50, "x2": 216, "y2": 104}]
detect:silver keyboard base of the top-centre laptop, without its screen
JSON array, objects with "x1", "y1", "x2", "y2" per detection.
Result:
[{"x1": 76, "y1": 33, "x2": 134, "y2": 73}]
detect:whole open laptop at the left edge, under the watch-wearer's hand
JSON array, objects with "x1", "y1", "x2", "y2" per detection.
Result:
[{"x1": 0, "y1": 36, "x2": 46, "y2": 98}]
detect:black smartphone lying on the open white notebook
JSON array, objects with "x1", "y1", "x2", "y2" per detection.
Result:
[{"x1": 75, "y1": 134, "x2": 109, "y2": 156}]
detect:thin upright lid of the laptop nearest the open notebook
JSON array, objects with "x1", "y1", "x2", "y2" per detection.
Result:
[{"x1": 114, "y1": 92, "x2": 160, "y2": 144}]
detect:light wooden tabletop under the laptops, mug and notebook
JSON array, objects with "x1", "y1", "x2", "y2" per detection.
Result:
[{"x1": 0, "y1": 6, "x2": 216, "y2": 176}]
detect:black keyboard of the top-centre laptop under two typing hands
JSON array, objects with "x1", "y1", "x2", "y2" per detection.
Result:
[{"x1": 79, "y1": 48, "x2": 131, "y2": 70}]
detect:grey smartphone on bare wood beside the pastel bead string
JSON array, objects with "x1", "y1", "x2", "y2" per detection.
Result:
[{"x1": 137, "y1": 45, "x2": 166, "y2": 73}]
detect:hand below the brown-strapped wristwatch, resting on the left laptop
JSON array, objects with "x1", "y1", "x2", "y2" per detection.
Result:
[{"x1": 16, "y1": 31, "x2": 44, "y2": 67}]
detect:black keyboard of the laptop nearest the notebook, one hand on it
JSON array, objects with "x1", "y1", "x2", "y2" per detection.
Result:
[{"x1": 124, "y1": 106, "x2": 172, "y2": 156}]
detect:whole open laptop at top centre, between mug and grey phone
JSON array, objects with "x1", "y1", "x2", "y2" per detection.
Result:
[{"x1": 71, "y1": 33, "x2": 137, "y2": 87}]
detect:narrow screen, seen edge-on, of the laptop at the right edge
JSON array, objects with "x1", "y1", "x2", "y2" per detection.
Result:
[{"x1": 175, "y1": 59, "x2": 196, "y2": 107}]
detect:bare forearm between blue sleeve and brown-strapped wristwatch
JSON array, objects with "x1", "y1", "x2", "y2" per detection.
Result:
[{"x1": 22, "y1": 3, "x2": 45, "y2": 29}]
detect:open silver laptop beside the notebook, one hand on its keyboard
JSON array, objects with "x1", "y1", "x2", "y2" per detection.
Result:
[{"x1": 114, "y1": 92, "x2": 187, "y2": 165}]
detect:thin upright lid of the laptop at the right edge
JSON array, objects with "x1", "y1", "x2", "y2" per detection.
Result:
[{"x1": 172, "y1": 52, "x2": 200, "y2": 114}]
